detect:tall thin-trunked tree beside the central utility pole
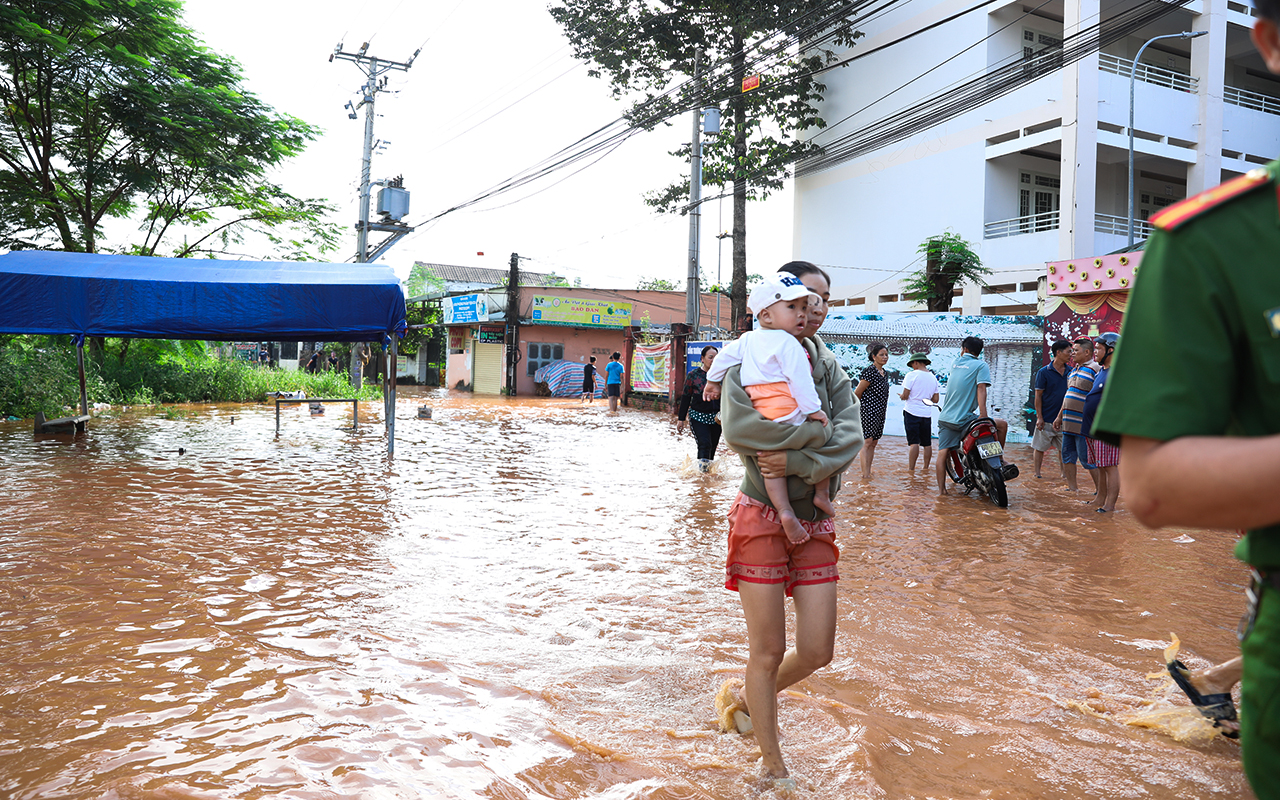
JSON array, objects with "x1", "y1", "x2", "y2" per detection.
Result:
[{"x1": 550, "y1": 0, "x2": 859, "y2": 328}]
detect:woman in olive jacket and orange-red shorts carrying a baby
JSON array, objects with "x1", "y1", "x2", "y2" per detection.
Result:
[{"x1": 721, "y1": 261, "x2": 863, "y2": 787}]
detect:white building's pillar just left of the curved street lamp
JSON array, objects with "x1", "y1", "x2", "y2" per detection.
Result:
[{"x1": 1057, "y1": 0, "x2": 1100, "y2": 259}]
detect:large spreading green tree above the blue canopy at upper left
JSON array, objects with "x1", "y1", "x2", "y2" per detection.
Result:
[{"x1": 0, "y1": 0, "x2": 338, "y2": 260}]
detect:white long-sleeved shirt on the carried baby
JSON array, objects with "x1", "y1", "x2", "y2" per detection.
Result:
[{"x1": 707, "y1": 328, "x2": 822, "y2": 425}]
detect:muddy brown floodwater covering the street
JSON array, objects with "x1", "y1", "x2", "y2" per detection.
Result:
[{"x1": 0, "y1": 392, "x2": 1249, "y2": 800}]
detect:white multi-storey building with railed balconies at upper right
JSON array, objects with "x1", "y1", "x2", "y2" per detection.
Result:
[{"x1": 794, "y1": 0, "x2": 1280, "y2": 314}]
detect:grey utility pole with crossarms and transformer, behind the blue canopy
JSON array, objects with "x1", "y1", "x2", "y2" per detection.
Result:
[{"x1": 329, "y1": 42, "x2": 422, "y2": 389}]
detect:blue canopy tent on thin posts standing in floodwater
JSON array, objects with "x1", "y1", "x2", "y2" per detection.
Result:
[{"x1": 0, "y1": 251, "x2": 407, "y2": 452}]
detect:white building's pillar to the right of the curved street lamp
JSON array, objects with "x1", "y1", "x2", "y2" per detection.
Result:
[{"x1": 1187, "y1": 0, "x2": 1226, "y2": 197}]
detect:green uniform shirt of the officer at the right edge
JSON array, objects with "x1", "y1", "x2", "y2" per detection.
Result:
[{"x1": 1093, "y1": 157, "x2": 1280, "y2": 568}]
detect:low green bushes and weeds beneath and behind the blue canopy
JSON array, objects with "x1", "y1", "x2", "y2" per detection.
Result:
[{"x1": 0, "y1": 337, "x2": 381, "y2": 417}]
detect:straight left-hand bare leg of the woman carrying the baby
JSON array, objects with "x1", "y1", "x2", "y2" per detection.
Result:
[{"x1": 737, "y1": 581, "x2": 790, "y2": 778}]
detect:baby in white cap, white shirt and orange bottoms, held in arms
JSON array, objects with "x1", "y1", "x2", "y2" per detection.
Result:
[{"x1": 703, "y1": 273, "x2": 836, "y2": 543}]
